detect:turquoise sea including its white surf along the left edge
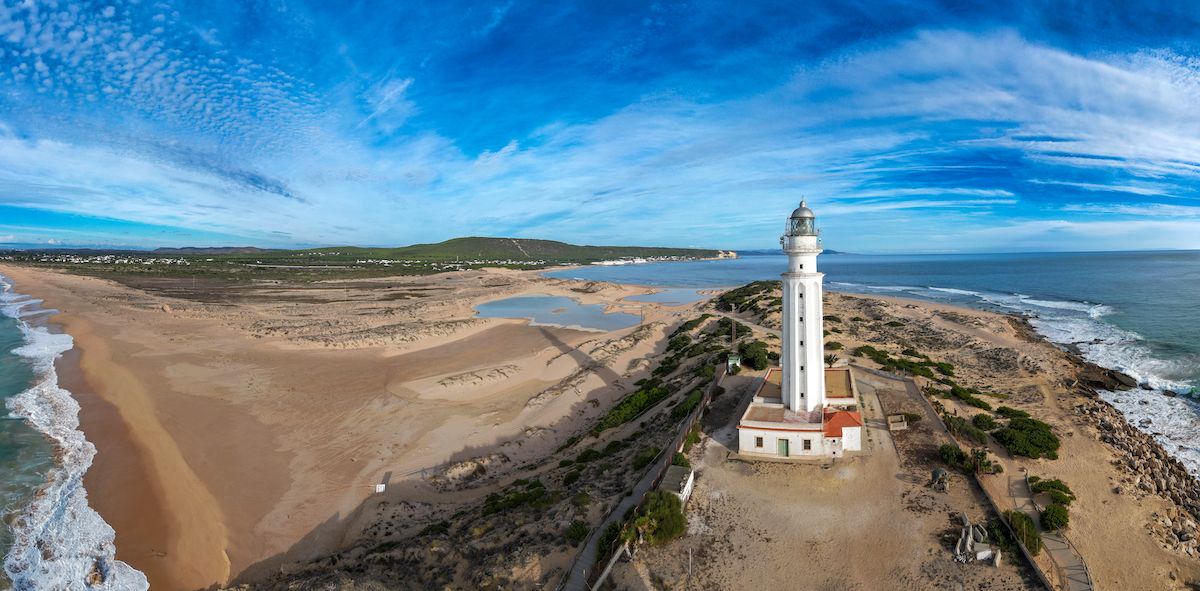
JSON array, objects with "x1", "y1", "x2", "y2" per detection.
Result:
[{"x1": 0, "y1": 276, "x2": 149, "y2": 591}]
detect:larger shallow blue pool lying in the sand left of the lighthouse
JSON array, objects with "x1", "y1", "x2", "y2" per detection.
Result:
[{"x1": 475, "y1": 296, "x2": 641, "y2": 332}]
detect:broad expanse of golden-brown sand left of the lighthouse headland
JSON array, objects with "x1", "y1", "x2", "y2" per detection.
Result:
[{"x1": 4, "y1": 265, "x2": 686, "y2": 589}]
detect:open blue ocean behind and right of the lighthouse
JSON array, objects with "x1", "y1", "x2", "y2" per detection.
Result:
[{"x1": 547, "y1": 251, "x2": 1200, "y2": 474}]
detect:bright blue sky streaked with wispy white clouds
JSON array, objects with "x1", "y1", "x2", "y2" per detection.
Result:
[{"x1": 0, "y1": 0, "x2": 1200, "y2": 252}]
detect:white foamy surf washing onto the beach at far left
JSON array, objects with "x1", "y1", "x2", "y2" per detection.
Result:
[{"x1": 0, "y1": 276, "x2": 150, "y2": 591}]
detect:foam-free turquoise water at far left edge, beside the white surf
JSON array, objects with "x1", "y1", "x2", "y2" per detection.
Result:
[{"x1": 0, "y1": 316, "x2": 54, "y2": 589}]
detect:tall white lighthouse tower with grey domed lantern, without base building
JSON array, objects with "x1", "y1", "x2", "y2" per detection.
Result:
[{"x1": 779, "y1": 201, "x2": 826, "y2": 412}]
